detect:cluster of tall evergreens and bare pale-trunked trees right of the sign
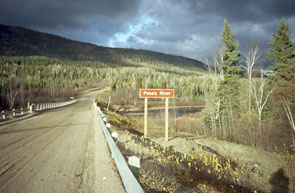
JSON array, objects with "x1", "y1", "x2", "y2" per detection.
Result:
[{"x1": 202, "y1": 19, "x2": 295, "y2": 150}]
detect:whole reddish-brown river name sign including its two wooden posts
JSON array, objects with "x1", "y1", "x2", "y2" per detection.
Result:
[{"x1": 139, "y1": 89, "x2": 174, "y2": 141}]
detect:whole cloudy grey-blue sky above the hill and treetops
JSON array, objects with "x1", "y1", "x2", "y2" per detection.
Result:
[{"x1": 0, "y1": 0, "x2": 295, "y2": 61}]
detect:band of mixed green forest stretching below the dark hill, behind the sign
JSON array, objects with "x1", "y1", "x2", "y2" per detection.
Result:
[{"x1": 0, "y1": 56, "x2": 206, "y2": 109}]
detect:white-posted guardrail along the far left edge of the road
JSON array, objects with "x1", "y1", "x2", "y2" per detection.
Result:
[{"x1": 0, "y1": 100, "x2": 77, "y2": 119}]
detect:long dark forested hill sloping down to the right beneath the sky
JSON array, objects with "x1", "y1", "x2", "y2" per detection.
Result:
[{"x1": 0, "y1": 25, "x2": 206, "y2": 71}]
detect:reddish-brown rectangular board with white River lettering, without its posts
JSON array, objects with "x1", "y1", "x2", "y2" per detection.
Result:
[{"x1": 139, "y1": 89, "x2": 174, "y2": 98}]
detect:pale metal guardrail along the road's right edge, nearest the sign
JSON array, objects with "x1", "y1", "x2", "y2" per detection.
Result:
[{"x1": 95, "y1": 104, "x2": 144, "y2": 193}]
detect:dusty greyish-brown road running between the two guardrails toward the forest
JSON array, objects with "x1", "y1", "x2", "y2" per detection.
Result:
[{"x1": 0, "y1": 91, "x2": 125, "y2": 193}]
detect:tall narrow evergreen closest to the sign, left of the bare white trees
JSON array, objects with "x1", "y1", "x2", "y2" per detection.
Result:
[{"x1": 218, "y1": 20, "x2": 241, "y2": 136}]
